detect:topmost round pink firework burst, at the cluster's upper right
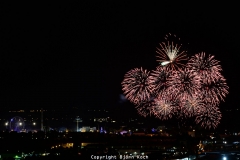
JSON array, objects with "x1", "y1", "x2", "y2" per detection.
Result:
[{"x1": 187, "y1": 52, "x2": 222, "y2": 82}]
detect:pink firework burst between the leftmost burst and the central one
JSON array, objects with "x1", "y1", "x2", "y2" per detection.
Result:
[{"x1": 149, "y1": 66, "x2": 172, "y2": 96}]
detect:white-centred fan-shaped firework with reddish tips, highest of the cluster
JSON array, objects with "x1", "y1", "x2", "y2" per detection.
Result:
[{"x1": 156, "y1": 34, "x2": 188, "y2": 70}]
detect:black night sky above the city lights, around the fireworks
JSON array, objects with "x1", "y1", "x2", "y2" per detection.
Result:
[{"x1": 0, "y1": 2, "x2": 240, "y2": 114}]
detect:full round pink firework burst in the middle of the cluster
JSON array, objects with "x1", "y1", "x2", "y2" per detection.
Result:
[{"x1": 168, "y1": 68, "x2": 201, "y2": 101}]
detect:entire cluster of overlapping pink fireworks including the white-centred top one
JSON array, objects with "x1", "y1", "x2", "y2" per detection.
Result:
[{"x1": 122, "y1": 34, "x2": 229, "y2": 129}]
